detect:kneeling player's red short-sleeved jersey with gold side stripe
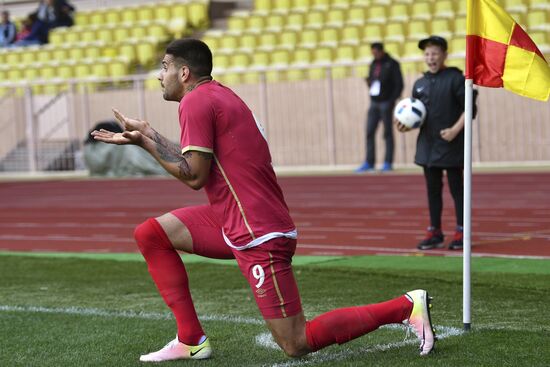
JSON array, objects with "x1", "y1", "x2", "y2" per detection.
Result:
[{"x1": 179, "y1": 81, "x2": 296, "y2": 249}]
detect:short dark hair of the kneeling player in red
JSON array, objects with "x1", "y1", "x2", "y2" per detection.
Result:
[{"x1": 166, "y1": 38, "x2": 212, "y2": 78}]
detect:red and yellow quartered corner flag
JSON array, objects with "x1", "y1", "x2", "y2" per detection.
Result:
[{"x1": 466, "y1": 0, "x2": 550, "y2": 101}]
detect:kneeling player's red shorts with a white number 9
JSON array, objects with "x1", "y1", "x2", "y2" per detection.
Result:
[{"x1": 171, "y1": 205, "x2": 302, "y2": 319}]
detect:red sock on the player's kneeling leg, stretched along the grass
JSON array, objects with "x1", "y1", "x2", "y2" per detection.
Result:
[{"x1": 306, "y1": 296, "x2": 413, "y2": 351}]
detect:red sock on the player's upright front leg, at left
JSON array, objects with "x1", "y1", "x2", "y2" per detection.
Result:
[{"x1": 134, "y1": 218, "x2": 204, "y2": 345}]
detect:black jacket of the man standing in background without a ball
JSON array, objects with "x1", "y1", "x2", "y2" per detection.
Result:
[{"x1": 366, "y1": 53, "x2": 403, "y2": 102}]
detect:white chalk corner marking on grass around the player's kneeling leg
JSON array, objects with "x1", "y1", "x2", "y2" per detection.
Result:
[{"x1": 262, "y1": 325, "x2": 463, "y2": 367}]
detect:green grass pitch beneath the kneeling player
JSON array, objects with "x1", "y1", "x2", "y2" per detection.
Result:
[{"x1": 0, "y1": 252, "x2": 550, "y2": 367}]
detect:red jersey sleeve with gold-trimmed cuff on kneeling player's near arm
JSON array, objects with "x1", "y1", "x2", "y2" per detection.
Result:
[{"x1": 179, "y1": 98, "x2": 215, "y2": 154}]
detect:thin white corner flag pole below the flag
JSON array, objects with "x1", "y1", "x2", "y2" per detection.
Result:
[{"x1": 462, "y1": 79, "x2": 474, "y2": 331}]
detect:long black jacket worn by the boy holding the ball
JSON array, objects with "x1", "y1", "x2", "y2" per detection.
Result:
[{"x1": 412, "y1": 67, "x2": 476, "y2": 168}]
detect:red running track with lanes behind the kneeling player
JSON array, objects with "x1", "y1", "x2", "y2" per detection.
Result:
[{"x1": 0, "y1": 172, "x2": 550, "y2": 258}]
